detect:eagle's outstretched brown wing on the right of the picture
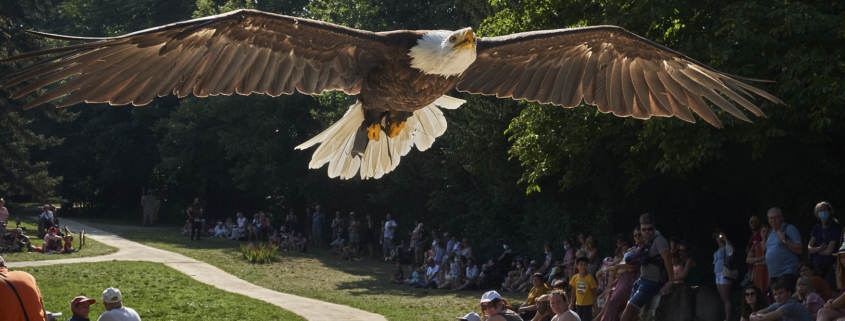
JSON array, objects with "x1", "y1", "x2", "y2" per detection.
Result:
[{"x1": 457, "y1": 26, "x2": 783, "y2": 127}]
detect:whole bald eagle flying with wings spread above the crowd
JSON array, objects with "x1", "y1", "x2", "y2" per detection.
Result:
[{"x1": 2, "y1": 10, "x2": 783, "y2": 179}]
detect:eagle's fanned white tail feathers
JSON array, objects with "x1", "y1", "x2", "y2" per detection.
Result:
[{"x1": 296, "y1": 96, "x2": 465, "y2": 179}]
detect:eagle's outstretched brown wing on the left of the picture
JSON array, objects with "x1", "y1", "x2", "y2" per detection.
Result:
[{"x1": 0, "y1": 10, "x2": 391, "y2": 108}]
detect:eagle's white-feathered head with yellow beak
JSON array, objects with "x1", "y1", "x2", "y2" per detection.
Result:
[{"x1": 408, "y1": 28, "x2": 478, "y2": 78}]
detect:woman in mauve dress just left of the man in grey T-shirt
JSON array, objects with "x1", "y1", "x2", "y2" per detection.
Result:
[{"x1": 601, "y1": 227, "x2": 645, "y2": 321}]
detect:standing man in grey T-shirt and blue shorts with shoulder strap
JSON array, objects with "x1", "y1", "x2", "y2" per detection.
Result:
[{"x1": 621, "y1": 214, "x2": 675, "y2": 321}]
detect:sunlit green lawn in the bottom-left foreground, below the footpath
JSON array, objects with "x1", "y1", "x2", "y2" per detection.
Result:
[{"x1": 12, "y1": 261, "x2": 305, "y2": 321}]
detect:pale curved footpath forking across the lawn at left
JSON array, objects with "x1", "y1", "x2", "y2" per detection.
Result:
[{"x1": 6, "y1": 218, "x2": 387, "y2": 320}]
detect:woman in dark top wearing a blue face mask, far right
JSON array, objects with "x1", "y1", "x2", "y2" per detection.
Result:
[{"x1": 807, "y1": 202, "x2": 842, "y2": 288}]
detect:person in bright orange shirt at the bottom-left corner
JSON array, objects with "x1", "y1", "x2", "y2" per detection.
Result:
[{"x1": 0, "y1": 256, "x2": 47, "y2": 321}]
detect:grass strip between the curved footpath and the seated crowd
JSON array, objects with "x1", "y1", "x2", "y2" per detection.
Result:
[{"x1": 120, "y1": 228, "x2": 527, "y2": 320}]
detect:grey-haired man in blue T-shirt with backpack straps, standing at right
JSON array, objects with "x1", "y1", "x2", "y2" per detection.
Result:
[{"x1": 766, "y1": 207, "x2": 804, "y2": 292}]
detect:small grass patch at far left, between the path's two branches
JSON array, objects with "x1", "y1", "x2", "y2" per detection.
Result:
[{"x1": 0, "y1": 216, "x2": 117, "y2": 262}]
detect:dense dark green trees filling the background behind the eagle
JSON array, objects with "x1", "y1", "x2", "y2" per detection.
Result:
[{"x1": 0, "y1": 0, "x2": 845, "y2": 262}]
